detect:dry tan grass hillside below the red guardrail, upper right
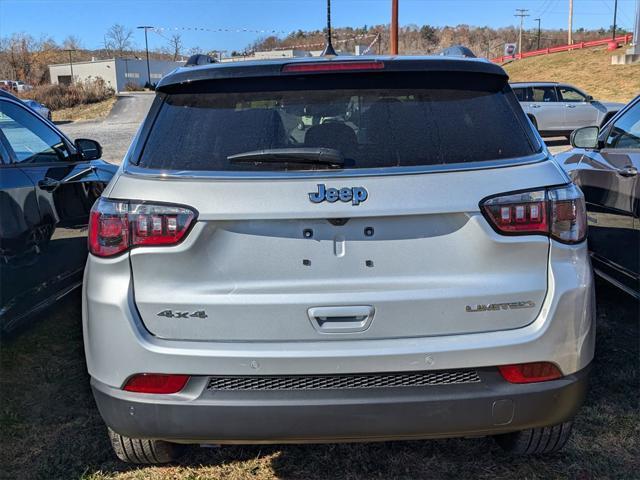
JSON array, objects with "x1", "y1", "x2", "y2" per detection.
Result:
[{"x1": 504, "y1": 47, "x2": 640, "y2": 103}]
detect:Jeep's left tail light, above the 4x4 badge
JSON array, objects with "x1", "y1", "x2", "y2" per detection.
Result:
[{"x1": 89, "y1": 198, "x2": 196, "y2": 257}]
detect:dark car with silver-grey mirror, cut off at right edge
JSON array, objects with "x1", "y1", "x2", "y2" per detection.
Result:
[{"x1": 556, "y1": 96, "x2": 640, "y2": 299}]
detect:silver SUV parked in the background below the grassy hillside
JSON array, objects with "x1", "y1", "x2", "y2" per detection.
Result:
[{"x1": 511, "y1": 82, "x2": 624, "y2": 137}]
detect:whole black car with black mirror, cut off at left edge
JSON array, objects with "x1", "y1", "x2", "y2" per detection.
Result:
[{"x1": 0, "y1": 91, "x2": 117, "y2": 333}]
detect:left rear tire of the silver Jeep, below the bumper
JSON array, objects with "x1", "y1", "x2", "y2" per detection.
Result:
[{"x1": 109, "y1": 428, "x2": 184, "y2": 464}]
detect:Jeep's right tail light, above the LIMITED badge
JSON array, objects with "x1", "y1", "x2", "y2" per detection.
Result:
[{"x1": 480, "y1": 184, "x2": 587, "y2": 243}]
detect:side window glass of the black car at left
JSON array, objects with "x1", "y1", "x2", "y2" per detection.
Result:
[{"x1": 0, "y1": 101, "x2": 70, "y2": 163}]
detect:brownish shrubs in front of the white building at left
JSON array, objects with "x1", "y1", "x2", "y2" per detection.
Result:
[{"x1": 20, "y1": 78, "x2": 115, "y2": 110}]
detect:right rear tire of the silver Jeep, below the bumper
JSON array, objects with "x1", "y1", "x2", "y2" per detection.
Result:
[{"x1": 494, "y1": 421, "x2": 573, "y2": 455}]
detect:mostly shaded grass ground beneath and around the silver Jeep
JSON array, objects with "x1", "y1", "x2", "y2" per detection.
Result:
[{"x1": 0, "y1": 284, "x2": 640, "y2": 480}]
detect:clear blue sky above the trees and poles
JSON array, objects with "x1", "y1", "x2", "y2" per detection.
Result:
[{"x1": 0, "y1": 0, "x2": 636, "y2": 52}]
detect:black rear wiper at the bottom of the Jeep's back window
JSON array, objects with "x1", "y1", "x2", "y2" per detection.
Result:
[{"x1": 227, "y1": 147, "x2": 344, "y2": 168}]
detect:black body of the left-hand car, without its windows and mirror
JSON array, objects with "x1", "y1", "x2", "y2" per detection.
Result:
[{"x1": 0, "y1": 89, "x2": 116, "y2": 332}]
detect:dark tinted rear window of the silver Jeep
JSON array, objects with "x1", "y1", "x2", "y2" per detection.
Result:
[{"x1": 138, "y1": 72, "x2": 540, "y2": 171}]
